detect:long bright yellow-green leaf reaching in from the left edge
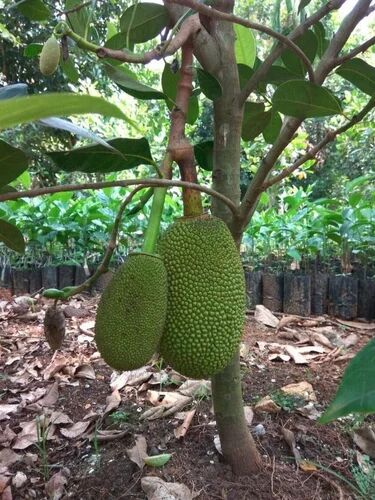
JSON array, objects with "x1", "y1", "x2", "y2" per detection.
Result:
[{"x1": 0, "y1": 92, "x2": 134, "y2": 130}]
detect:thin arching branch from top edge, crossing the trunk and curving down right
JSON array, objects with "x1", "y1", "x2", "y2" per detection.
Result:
[{"x1": 166, "y1": 0, "x2": 318, "y2": 82}]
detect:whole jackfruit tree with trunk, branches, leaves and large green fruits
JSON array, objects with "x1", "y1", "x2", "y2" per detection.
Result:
[{"x1": 0, "y1": 0, "x2": 375, "y2": 474}]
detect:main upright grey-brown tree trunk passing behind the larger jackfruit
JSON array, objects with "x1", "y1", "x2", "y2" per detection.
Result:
[{"x1": 212, "y1": 2, "x2": 261, "y2": 475}]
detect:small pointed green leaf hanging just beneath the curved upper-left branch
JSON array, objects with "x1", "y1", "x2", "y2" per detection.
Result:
[{"x1": 105, "y1": 64, "x2": 166, "y2": 100}]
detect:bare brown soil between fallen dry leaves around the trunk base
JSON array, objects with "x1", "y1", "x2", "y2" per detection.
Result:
[{"x1": 0, "y1": 292, "x2": 375, "y2": 500}]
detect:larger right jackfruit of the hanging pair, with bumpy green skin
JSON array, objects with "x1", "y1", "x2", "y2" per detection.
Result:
[{"x1": 159, "y1": 216, "x2": 245, "y2": 378}]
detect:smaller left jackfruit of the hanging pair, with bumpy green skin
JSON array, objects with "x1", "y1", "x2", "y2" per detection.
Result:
[{"x1": 95, "y1": 253, "x2": 167, "y2": 370}]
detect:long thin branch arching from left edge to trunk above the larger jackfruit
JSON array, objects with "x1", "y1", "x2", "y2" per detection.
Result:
[{"x1": 0, "y1": 179, "x2": 238, "y2": 216}]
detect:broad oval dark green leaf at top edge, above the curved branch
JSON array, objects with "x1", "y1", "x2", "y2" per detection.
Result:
[{"x1": 120, "y1": 2, "x2": 169, "y2": 43}]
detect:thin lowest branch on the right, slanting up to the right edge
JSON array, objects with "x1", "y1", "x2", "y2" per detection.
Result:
[{"x1": 262, "y1": 97, "x2": 375, "y2": 191}]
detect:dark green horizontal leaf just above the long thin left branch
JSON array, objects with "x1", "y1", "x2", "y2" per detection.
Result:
[{"x1": 47, "y1": 137, "x2": 154, "y2": 173}]
